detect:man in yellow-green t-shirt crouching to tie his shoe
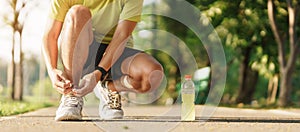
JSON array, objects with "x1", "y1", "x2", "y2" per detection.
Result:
[{"x1": 43, "y1": 0, "x2": 163, "y2": 121}]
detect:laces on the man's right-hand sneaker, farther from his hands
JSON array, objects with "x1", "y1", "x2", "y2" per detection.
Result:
[{"x1": 108, "y1": 90, "x2": 122, "y2": 110}]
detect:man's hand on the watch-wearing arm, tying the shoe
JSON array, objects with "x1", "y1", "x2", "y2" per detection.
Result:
[{"x1": 73, "y1": 72, "x2": 97, "y2": 97}]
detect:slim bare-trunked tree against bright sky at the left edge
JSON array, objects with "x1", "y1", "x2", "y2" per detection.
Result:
[{"x1": 4, "y1": 0, "x2": 28, "y2": 100}]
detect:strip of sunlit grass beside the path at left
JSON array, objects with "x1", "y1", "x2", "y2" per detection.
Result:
[{"x1": 0, "y1": 98, "x2": 54, "y2": 117}]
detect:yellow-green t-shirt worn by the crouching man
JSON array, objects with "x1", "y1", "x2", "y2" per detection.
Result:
[{"x1": 50, "y1": 0, "x2": 143, "y2": 45}]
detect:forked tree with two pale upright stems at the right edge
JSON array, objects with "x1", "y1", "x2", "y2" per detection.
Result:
[{"x1": 267, "y1": 0, "x2": 300, "y2": 106}]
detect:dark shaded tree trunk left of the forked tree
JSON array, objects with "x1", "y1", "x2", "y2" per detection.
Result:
[{"x1": 236, "y1": 47, "x2": 258, "y2": 104}]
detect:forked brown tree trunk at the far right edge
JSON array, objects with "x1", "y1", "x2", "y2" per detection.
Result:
[{"x1": 268, "y1": 0, "x2": 300, "y2": 107}]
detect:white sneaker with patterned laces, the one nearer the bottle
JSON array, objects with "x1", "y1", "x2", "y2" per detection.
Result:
[{"x1": 94, "y1": 83, "x2": 124, "y2": 119}]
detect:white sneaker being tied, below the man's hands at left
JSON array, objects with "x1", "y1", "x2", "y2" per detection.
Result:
[{"x1": 55, "y1": 95, "x2": 83, "y2": 121}]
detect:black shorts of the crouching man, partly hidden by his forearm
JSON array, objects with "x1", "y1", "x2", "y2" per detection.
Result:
[{"x1": 83, "y1": 40, "x2": 142, "y2": 80}]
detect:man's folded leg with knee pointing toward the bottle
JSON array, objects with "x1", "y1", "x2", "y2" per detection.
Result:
[{"x1": 108, "y1": 53, "x2": 164, "y2": 93}]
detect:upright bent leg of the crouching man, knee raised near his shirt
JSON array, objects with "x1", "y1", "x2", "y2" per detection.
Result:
[{"x1": 60, "y1": 5, "x2": 93, "y2": 87}]
